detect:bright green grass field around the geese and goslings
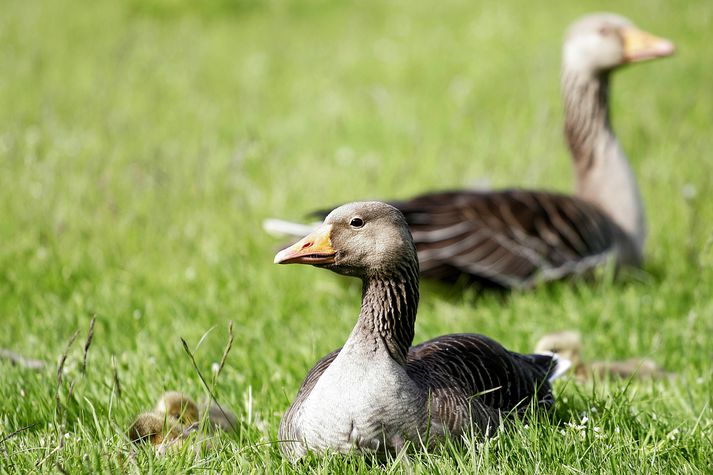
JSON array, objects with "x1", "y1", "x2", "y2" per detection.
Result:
[{"x1": 0, "y1": 0, "x2": 713, "y2": 474}]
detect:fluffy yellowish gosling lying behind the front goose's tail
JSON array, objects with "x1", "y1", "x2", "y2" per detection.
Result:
[{"x1": 535, "y1": 330, "x2": 674, "y2": 380}]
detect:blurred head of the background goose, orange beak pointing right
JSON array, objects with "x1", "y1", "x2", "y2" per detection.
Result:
[{"x1": 563, "y1": 13, "x2": 675, "y2": 75}]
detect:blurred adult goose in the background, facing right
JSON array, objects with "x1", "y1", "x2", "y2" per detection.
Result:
[{"x1": 266, "y1": 13, "x2": 674, "y2": 288}]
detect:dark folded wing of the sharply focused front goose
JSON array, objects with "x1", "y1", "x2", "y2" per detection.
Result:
[{"x1": 406, "y1": 334, "x2": 558, "y2": 432}]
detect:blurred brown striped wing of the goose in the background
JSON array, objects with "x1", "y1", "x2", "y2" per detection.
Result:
[{"x1": 391, "y1": 190, "x2": 623, "y2": 287}]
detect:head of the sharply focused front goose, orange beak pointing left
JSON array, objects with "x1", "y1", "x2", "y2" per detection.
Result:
[{"x1": 275, "y1": 201, "x2": 418, "y2": 278}]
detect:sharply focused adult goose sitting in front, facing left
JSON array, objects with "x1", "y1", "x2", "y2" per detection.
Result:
[{"x1": 275, "y1": 202, "x2": 566, "y2": 460}]
